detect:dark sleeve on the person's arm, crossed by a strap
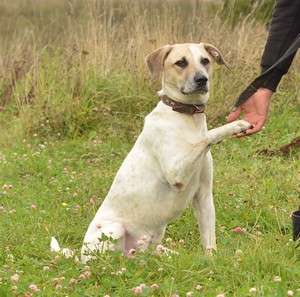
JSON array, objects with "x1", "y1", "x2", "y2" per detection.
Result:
[{"x1": 261, "y1": 0, "x2": 300, "y2": 92}]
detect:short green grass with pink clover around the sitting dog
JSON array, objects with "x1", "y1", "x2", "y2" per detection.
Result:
[{"x1": 0, "y1": 92, "x2": 300, "y2": 297}]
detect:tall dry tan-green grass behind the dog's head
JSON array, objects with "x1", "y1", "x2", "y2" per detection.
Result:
[{"x1": 0, "y1": 0, "x2": 293, "y2": 140}]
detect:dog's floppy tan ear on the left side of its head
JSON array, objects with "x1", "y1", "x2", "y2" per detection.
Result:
[{"x1": 146, "y1": 45, "x2": 172, "y2": 80}]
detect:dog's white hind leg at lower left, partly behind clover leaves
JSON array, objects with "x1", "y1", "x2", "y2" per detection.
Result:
[{"x1": 81, "y1": 221, "x2": 125, "y2": 263}]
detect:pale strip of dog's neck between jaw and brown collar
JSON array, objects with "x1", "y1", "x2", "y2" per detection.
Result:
[{"x1": 158, "y1": 85, "x2": 209, "y2": 105}]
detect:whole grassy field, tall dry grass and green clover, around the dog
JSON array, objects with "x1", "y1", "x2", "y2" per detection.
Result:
[{"x1": 0, "y1": 0, "x2": 300, "y2": 297}]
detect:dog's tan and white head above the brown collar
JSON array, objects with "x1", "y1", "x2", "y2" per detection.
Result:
[{"x1": 146, "y1": 43, "x2": 226, "y2": 103}]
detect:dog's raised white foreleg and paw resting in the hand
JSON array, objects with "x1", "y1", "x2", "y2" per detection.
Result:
[{"x1": 207, "y1": 120, "x2": 251, "y2": 144}]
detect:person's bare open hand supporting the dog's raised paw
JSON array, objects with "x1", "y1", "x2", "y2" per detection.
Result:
[{"x1": 227, "y1": 88, "x2": 273, "y2": 137}]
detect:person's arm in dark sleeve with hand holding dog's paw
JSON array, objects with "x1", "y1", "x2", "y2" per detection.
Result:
[{"x1": 227, "y1": 0, "x2": 300, "y2": 135}]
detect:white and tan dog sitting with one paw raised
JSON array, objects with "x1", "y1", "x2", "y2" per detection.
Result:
[{"x1": 82, "y1": 43, "x2": 250, "y2": 262}]
